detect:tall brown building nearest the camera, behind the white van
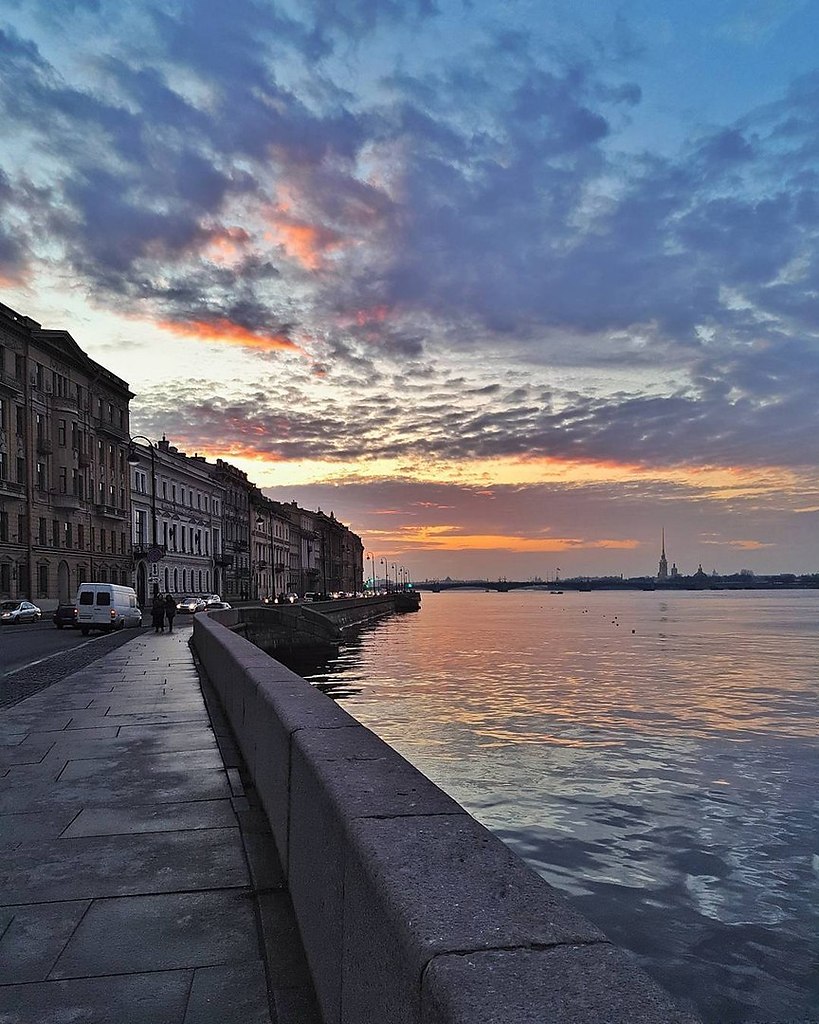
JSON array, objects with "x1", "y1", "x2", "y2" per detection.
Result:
[{"x1": 0, "y1": 304, "x2": 133, "y2": 606}]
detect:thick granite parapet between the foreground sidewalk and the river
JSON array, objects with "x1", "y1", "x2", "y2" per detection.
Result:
[{"x1": 193, "y1": 611, "x2": 695, "y2": 1024}]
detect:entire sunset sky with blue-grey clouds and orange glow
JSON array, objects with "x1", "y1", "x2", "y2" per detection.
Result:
[{"x1": 0, "y1": 0, "x2": 819, "y2": 580}]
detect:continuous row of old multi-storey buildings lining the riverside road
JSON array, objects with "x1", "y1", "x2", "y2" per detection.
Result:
[{"x1": 0, "y1": 303, "x2": 363, "y2": 610}]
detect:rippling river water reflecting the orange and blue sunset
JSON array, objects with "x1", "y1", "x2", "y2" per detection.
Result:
[{"x1": 301, "y1": 591, "x2": 819, "y2": 1024}]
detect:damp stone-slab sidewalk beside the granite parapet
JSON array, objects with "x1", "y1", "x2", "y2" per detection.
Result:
[{"x1": 0, "y1": 624, "x2": 319, "y2": 1024}]
